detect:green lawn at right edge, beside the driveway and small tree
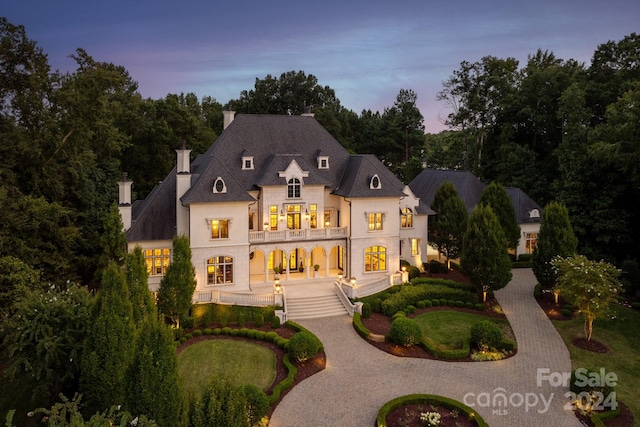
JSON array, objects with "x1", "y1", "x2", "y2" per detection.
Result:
[{"x1": 553, "y1": 305, "x2": 640, "y2": 426}]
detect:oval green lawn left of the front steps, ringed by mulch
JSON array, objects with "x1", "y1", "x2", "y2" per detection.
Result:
[{"x1": 178, "y1": 339, "x2": 276, "y2": 391}]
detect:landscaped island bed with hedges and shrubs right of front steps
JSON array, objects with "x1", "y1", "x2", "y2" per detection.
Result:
[{"x1": 354, "y1": 270, "x2": 516, "y2": 361}]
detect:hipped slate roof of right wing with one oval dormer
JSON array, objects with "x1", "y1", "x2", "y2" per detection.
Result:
[{"x1": 334, "y1": 154, "x2": 406, "y2": 198}]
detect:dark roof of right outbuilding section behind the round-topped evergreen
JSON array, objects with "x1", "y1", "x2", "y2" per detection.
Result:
[{"x1": 409, "y1": 169, "x2": 484, "y2": 212}]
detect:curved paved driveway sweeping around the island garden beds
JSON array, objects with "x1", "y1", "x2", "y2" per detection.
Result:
[{"x1": 269, "y1": 269, "x2": 580, "y2": 427}]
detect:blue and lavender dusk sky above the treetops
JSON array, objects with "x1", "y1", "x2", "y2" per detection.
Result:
[{"x1": 5, "y1": 0, "x2": 640, "y2": 133}]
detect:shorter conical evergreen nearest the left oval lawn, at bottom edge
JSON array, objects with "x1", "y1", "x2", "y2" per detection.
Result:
[{"x1": 124, "y1": 317, "x2": 182, "y2": 426}]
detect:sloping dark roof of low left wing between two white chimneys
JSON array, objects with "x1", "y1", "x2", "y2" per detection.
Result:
[{"x1": 127, "y1": 171, "x2": 176, "y2": 242}]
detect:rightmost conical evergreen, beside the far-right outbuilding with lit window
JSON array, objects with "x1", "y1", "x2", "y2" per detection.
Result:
[{"x1": 532, "y1": 202, "x2": 578, "y2": 289}]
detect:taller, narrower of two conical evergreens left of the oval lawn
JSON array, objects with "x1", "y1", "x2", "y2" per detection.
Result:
[{"x1": 80, "y1": 261, "x2": 135, "y2": 414}]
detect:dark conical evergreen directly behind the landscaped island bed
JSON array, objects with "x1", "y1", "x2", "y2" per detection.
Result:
[{"x1": 460, "y1": 204, "x2": 511, "y2": 300}]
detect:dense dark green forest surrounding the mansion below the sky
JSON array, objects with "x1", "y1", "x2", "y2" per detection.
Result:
[{"x1": 0, "y1": 18, "x2": 640, "y2": 290}]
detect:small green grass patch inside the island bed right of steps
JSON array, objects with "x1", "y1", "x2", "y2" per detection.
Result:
[{"x1": 413, "y1": 310, "x2": 513, "y2": 349}]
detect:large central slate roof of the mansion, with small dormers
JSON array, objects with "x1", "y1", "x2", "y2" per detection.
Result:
[{"x1": 191, "y1": 114, "x2": 349, "y2": 197}]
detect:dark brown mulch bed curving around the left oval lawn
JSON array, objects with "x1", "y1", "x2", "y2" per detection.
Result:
[{"x1": 177, "y1": 324, "x2": 327, "y2": 416}]
